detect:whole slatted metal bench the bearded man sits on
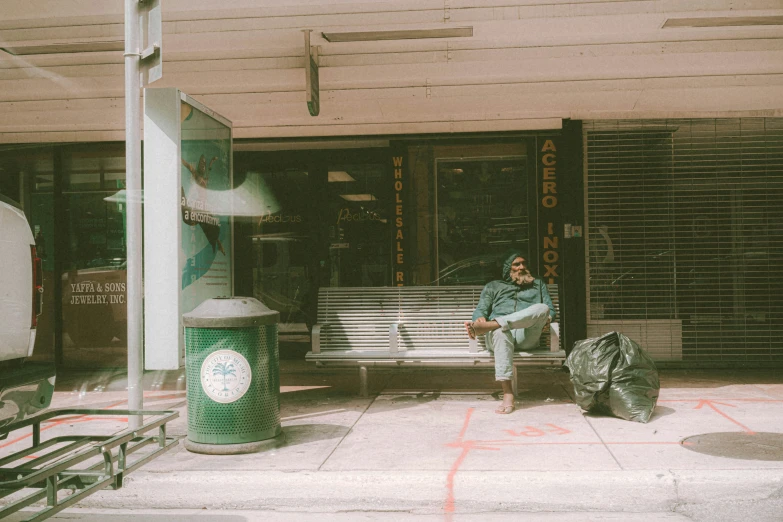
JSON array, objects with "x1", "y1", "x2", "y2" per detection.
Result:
[{"x1": 305, "y1": 285, "x2": 565, "y2": 396}]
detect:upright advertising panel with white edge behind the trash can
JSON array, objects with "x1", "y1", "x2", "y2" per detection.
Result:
[{"x1": 144, "y1": 88, "x2": 233, "y2": 370}]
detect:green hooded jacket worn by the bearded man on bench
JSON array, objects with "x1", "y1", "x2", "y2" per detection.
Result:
[{"x1": 473, "y1": 252, "x2": 555, "y2": 321}]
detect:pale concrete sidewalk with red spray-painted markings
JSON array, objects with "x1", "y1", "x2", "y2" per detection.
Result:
[{"x1": 0, "y1": 361, "x2": 783, "y2": 522}]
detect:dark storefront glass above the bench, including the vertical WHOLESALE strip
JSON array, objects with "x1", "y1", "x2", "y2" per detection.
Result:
[{"x1": 234, "y1": 144, "x2": 535, "y2": 335}]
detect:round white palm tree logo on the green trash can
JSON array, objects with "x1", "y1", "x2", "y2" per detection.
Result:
[{"x1": 200, "y1": 350, "x2": 252, "y2": 404}]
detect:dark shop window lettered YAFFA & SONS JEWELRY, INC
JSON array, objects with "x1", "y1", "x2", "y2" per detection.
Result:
[{"x1": 61, "y1": 145, "x2": 127, "y2": 366}]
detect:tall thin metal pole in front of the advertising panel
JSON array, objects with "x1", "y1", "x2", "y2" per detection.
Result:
[{"x1": 125, "y1": 0, "x2": 144, "y2": 428}]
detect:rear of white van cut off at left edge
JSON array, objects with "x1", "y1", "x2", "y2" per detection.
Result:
[{"x1": 0, "y1": 196, "x2": 55, "y2": 427}]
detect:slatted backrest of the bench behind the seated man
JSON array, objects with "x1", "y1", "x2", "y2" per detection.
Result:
[{"x1": 318, "y1": 285, "x2": 559, "y2": 351}]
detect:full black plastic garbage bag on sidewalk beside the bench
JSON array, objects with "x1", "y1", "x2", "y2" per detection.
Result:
[{"x1": 565, "y1": 332, "x2": 661, "y2": 422}]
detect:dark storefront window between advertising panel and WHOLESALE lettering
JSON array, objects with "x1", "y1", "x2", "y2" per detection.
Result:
[{"x1": 234, "y1": 152, "x2": 393, "y2": 335}]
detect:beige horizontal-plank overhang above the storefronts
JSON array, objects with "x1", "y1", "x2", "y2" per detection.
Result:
[{"x1": 0, "y1": 0, "x2": 783, "y2": 143}]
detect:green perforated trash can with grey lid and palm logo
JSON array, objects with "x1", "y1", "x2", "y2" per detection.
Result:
[{"x1": 182, "y1": 297, "x2": 281, "y2": 454}]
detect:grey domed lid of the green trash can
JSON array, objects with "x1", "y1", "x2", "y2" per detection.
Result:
[{"x1": 182, "y1": 297, "x2": 280, "y2": 328}]
